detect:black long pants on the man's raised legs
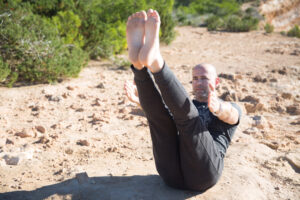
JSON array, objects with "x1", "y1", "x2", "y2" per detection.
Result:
[{"x1": 132, "y1": 64, "x2": 223, "y2": 191}]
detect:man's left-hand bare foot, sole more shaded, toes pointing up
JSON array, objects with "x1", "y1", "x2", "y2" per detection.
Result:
[{"x1": 126, "y1": 11, "x2": 147, "y2": 69}]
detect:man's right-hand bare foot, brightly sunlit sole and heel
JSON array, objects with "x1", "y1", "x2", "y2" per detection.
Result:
[{"x1": 139, "y1": 9, "x2": 164, "y2": 73}]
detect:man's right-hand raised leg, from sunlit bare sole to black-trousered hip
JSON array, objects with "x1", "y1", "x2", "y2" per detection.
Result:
[{"x1": 139, "y1": 10, "x2": 223, "y2": 191}]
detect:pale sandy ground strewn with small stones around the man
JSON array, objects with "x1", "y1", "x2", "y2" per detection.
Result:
[{"x1": 0, "y1": 27, "x2": 300, "y2": 200}]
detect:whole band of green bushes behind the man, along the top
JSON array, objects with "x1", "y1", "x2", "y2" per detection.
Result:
[{"x1": 0, "y1": 0, "x2": 298, "y2": 87}]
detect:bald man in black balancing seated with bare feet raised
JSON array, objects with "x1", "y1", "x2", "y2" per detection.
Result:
[{"x1": 125, "y1": 9, "x2": 241, "y2": 192}]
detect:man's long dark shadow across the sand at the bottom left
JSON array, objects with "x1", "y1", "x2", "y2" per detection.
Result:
[{"x1": 0, "y1": 175, "x2": 199, "y2": 200}]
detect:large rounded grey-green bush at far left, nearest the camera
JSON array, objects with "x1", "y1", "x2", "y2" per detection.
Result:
[{"x1": 0, "y1": 9, "x2": 87, "y2": 86}]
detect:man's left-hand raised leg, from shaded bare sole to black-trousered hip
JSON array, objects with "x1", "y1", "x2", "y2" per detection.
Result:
[{"x1": 127, "y1": 12, "x2": 183, "y2": 188}]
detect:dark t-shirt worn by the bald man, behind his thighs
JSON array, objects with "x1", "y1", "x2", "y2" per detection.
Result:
[{"x1": 193, "y1": 100, "x2": 242, "y2": 156}]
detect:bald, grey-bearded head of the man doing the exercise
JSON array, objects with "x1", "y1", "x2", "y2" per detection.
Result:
[{"x1": 192, "y1": 65, "x2": 217, "y2": 102}]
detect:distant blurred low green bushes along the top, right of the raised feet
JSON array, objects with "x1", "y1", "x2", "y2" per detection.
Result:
[{"x1": 176, "y1": 0, "x2": 261, "y2": 32}]
